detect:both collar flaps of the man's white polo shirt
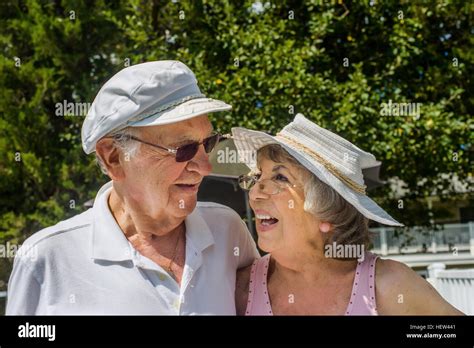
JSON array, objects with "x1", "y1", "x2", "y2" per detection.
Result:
[{"x1": 91, "y1": 181, "x2": 214, "y2": 261}]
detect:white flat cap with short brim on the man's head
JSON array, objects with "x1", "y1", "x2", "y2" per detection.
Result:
[{"x1": 82, "y1": 60, "x2": 232, "y2": 154}]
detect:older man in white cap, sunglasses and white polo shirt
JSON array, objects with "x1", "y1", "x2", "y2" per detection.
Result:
[{"x1": 7, "y1": 61, "x2": 258, "y2": 315}]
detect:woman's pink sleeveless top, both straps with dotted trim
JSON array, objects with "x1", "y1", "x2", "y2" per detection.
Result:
[{"x1": 245, "y1": 252, "x2": 378, "y2": 315}]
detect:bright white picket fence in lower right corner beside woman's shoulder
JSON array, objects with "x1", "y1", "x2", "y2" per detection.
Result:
[{"x1": 427, "y1": 263, "x2": 474, "y2": 315}]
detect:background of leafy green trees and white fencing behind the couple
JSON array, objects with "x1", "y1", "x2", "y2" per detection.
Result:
[{"x1": 0, "y1": 0, "x2": 474, "y2": 314}]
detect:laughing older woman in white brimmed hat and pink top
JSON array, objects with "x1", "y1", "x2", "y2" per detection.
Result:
[{"x1": 233, "y1": 115, "x2": 462, "y2": 315}]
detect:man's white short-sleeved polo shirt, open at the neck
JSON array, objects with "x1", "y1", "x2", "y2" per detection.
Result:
[{"x1": 6, "y1": 183, "x2": 259, "y2": 315}]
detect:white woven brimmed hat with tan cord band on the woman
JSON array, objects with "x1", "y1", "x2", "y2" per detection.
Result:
[{"x1": 232, "y1": 114, "x2": 403, "y2": 226}]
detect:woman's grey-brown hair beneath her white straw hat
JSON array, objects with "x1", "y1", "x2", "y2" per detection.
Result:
[{"x1": 257, "y1": 144, "x2": 370, "y2": 249}]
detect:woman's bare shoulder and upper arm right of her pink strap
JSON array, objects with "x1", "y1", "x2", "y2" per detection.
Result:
[{"x1": 375, "y1": 259, "x2": 463, "y2": 315}]
